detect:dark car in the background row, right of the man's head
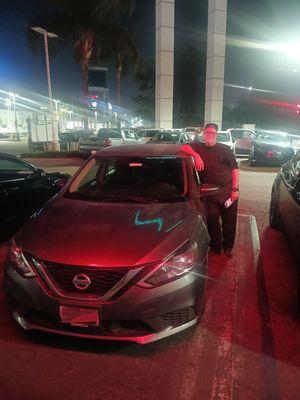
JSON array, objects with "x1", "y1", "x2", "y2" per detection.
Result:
[{"x1": 249, "y1": 132, "x2": 294, "y2": 166}]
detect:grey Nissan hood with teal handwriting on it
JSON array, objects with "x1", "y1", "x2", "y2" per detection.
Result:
[{"x1": 20, "y1": 196, "x2": 197, "y2": 267}]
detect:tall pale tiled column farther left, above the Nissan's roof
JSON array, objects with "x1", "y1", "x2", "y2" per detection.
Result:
[{"x1": 155, "y1": 0, "x2": 175, "y2": 129}]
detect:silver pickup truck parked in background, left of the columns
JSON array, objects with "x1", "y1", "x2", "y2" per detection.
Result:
[{"x1": 79, "y1": 128, "x2": 140, "y2": 156}]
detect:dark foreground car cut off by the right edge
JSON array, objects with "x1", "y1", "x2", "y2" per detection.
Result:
[{"x1": 269, "y1": 150, "x2": 300, "y2": 310}]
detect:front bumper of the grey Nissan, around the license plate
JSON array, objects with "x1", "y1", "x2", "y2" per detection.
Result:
[{"x1": 4, "y1": 264, "x2": 206, "y2": 344}]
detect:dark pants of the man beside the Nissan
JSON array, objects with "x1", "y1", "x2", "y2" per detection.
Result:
[{"x1": 207, "y1": 200, "x2": 238, "y2": 252}]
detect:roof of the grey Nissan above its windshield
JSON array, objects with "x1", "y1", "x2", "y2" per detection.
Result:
[{"x1": 95, "y1": 143, "x2": 185, "y2": 157}]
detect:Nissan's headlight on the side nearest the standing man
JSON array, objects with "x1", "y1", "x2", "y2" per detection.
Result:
[{"x1": 138, "y1": 243, "x2": 198, "y2": 288}]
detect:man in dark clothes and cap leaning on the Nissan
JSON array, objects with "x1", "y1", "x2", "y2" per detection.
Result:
[{"x1": 180, "y1": 123, "x2": 239, "y2": 257}]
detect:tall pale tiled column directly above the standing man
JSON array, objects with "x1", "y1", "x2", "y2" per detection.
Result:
[{"x1": 205, "y1": 0, "x2": 227, "y2": 129}]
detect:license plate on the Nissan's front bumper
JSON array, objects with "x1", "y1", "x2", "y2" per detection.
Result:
[{"x1": 59, "y1": 306, "x2": 100, "y2": 326}]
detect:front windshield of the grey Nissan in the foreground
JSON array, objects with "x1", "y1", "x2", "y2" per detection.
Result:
[{"x1": 66, "y1": 156, "x2": 186, "y2": 202}]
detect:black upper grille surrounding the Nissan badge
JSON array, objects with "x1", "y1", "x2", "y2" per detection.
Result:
[{"x1": 43, "y1": 262, "x2": 129, "y2": 296}]
